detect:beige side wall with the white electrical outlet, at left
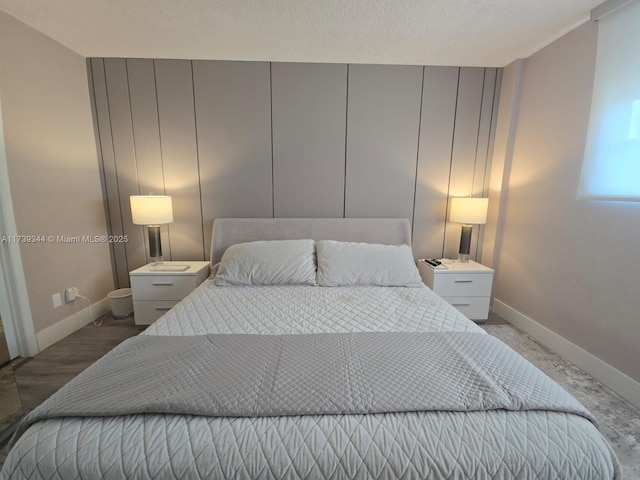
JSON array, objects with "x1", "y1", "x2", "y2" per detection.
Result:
[{"x1": 0, "y1": 12, "x2": 113, "y2": 332}]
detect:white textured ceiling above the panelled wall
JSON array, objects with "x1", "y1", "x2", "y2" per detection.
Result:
[{"x1": 0, "y1": 0, "x2": 602, "y2": 66}]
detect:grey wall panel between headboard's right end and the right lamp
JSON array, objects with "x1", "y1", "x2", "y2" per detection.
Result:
[{"x1": 413, "y1": 67, "x2": 460, "y2": 258}]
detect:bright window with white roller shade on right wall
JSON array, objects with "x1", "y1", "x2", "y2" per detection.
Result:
[{"x1": 578, "y1": 1, "x2": 640, "y2": 201}]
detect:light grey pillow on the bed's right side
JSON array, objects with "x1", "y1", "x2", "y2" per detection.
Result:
[{"x1": 316, "y1": 240, "x2": 423, "y2": 287}]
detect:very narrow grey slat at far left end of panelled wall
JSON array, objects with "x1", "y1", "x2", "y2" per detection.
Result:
[{"x1": 91, "y1": 58, "x2": 129, "y2": 288}]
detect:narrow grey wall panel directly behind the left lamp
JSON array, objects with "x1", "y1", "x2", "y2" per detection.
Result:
[{"x1": 127, "y1": 59, "x2": 171, "y2": 261}]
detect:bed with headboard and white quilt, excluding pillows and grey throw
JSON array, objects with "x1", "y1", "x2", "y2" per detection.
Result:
[{"x1": 0, "y1": 219, "x2": 620, "y2": 479}]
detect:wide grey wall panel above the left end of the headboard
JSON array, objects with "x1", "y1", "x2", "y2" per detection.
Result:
[{"x1": 193, "y1": 61, "x2": 273, "y2": 258}]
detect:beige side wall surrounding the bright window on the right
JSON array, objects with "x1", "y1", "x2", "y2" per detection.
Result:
[{"x1": 494, "y1": 22, "x2": 640, "y2": 381}]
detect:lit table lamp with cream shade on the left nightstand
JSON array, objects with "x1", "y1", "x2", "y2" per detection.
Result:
[{"x1": 129, "y1": 195, "x2": 173, "y2": 265}]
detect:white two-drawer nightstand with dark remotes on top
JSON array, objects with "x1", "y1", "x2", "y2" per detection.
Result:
[{"x1": 418, "y1": 260, "x2": 494, "y2": 321}]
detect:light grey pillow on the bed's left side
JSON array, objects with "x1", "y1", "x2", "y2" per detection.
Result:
[{"x1": 214, "y1": 240, "x2": 316, "y2": 285}]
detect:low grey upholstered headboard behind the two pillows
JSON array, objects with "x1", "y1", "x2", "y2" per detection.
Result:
[{"x1": 211, "y1": 218, "x2": 411, "y2": 265}]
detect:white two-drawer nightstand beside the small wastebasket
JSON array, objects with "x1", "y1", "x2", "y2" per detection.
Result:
[{"x1": 129, "y1": 261, "x2": 210, "y2": 325}]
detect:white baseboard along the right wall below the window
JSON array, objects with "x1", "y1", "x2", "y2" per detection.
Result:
[{"x1": 492, "y1": 299, "x2": 640, "y2": 408}]
